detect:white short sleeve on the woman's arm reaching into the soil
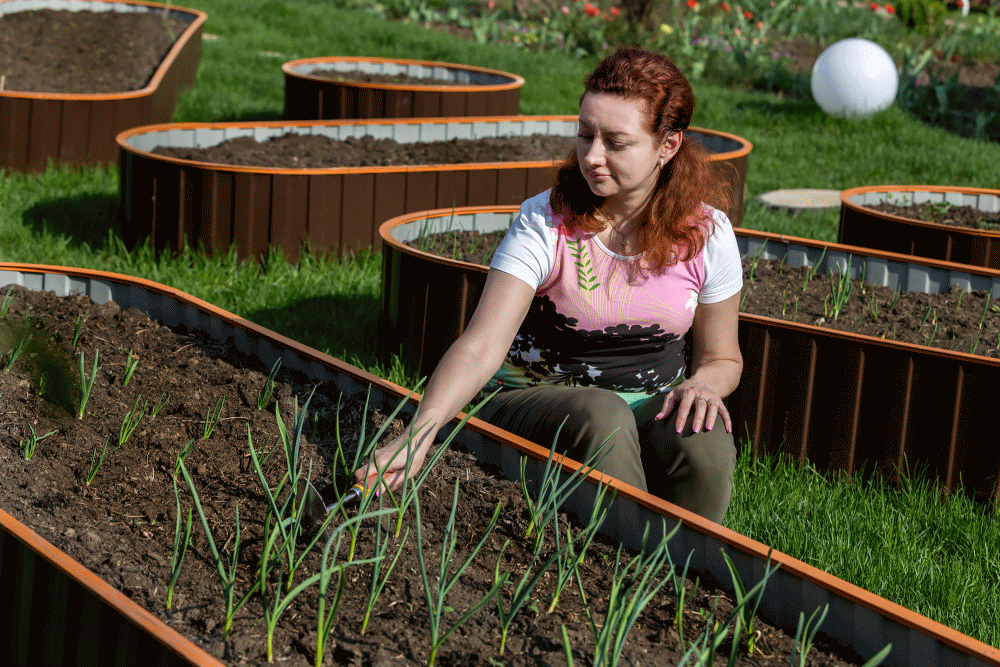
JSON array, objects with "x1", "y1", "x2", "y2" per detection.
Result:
[{"x1": 490, "y1": 190, "x2": 555, "y2": 290}]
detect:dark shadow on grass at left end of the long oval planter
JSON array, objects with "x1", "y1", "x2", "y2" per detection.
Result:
[{"x1": 23, "y1": 194, "x2": 121, "y2": 248}]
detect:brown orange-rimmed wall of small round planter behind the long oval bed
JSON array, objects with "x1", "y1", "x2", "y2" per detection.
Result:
[{"x1": 281, "y1": 57, "x2": 524, "y2": 120}]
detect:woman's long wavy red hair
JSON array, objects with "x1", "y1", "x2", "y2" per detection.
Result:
[{"x1": 551, "y1": 47, "x2": 732, "y2": 271}]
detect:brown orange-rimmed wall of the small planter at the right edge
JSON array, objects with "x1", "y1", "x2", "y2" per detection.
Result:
[{"x1": 837, "y1": 185, "x2": 1000, "y2": 269}]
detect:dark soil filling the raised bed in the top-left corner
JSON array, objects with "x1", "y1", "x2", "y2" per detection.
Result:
[{"x1": 0, "y1": 9, "x2": 188, "y2": 93}]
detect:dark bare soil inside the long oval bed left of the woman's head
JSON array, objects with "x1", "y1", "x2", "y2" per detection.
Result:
[{"x1": 147, "y1": 133, "x2": 575, "y2": 169}]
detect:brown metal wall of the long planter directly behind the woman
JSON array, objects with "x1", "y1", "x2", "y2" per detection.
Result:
[{"x1": 379, "y1": 207, "x2": 1000, "y2": 505}]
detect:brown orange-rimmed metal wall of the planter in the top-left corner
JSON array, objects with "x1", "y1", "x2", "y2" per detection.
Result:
[{"x1": 0, "y1": 0, "x2": 207, "y2": 172}]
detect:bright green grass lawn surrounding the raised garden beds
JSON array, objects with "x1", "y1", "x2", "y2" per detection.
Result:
[{"x1": 0, "y1": 0, "x2": 1000, "y2": 646}]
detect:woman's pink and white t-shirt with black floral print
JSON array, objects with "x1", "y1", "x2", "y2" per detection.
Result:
[{"x1": 486, "y1": 191, "x2": 743, "y2": 405}]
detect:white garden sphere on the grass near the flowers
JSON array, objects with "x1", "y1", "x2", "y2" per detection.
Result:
[{"x1": 810, "y1": 37, "x2": 899, "y2": 118}]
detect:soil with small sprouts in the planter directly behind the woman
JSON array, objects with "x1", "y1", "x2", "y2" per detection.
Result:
[{"x1": 408, "y1": 231, "x2": 1000, "y2": 358}]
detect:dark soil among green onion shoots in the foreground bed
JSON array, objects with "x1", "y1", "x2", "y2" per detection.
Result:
[{"x1": 0, "y1": 287, "x2": 876, "y2": 666}]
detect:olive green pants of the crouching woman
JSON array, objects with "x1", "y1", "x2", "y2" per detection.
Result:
[{"x1": 478, "y1": 385, "x2": 736, "y2": 523}]
